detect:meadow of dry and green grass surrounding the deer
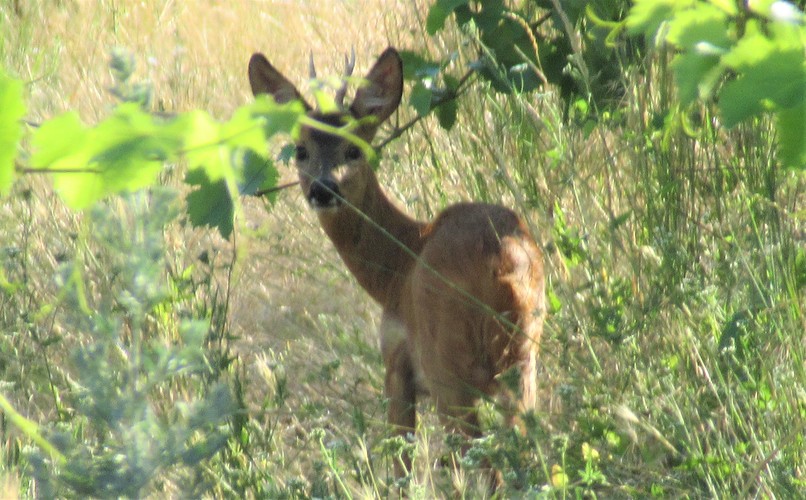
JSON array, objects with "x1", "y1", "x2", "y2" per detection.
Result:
[{"x1": 0, "y1": 0, "x2": 806, "y2": 498}]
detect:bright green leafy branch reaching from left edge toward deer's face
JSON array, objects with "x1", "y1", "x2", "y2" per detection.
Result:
[{"x1": 0, "y1": 69, "x2": 303, "y2": 238}]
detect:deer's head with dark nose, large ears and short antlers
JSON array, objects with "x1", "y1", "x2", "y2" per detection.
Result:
[{"x1": 249, "y1": 47, "x2": 403, "y2": 210}]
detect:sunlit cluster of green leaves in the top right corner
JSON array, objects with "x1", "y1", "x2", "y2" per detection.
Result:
[{"x1": 626, "y1": 0, "x2": 806, "y2": 169}]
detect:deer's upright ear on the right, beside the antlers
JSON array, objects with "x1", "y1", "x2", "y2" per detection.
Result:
[{"x1": 350, "y1": 47, "x2": 403, "y2": 123}]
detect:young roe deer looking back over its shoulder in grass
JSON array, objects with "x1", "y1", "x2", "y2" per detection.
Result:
[{"x1": 249, "y1": 47, "x2": 545, "y2": 484}]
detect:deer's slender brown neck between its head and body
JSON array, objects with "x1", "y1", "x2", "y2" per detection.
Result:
[{"x1": 319, "y1": 171, "x2": 426, "y2": 310}]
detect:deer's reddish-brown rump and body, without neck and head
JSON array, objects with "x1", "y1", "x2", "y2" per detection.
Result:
[{"x1": 381, "y1": 203, "x2": 544, "y2": 428}]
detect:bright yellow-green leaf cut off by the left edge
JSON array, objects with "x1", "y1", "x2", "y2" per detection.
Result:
[{"x1": 0, "y1": 72, "x2": 25, "y2": 196}]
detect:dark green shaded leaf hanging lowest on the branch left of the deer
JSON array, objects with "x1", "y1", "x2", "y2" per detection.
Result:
[{"x1": 185, "y1": 169, "x2": 235, "y2": 238}]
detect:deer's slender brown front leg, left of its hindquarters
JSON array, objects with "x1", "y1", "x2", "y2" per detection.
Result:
[{"x1": 381, "y1": 316, "x2": 417, "y2": 479}]
